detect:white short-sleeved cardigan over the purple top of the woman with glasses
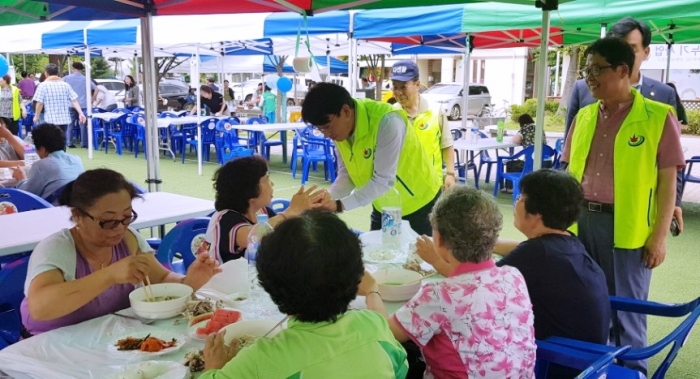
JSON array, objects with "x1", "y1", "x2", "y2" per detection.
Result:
[{"x1": 24, "y1": 228, "x2": 153, "y2": 296}]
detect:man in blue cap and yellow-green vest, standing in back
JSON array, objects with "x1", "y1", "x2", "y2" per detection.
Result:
[{"x1": 391, "y1": 60, "x2": 455, "y2": 189}]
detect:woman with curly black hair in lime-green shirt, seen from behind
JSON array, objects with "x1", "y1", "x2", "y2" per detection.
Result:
[{"x1": 201, "y1": 210, "x2": 408, "y2": 379}]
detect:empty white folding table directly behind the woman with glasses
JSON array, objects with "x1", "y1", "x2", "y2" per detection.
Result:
[{"x1": 0, "y1": 192, "x2": 214, "y2": 256}]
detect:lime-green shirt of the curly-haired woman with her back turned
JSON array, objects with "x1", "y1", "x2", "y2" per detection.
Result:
[{"x1": 200, "y1": 310, "x2": 408, "y2": 379}]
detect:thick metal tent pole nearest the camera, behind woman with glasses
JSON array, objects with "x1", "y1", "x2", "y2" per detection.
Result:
[{"x1": 142, "y1": 12, "x2": 162, "y2": 193}]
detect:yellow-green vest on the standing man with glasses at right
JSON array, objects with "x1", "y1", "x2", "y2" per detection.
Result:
[{"x1": 569, "y1": 89, "x2": 673, "y2": 249}]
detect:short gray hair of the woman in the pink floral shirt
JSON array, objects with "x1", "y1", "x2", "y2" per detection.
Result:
[{"x1": 430, "y1": 186, "x2": 503, "y2": 263}]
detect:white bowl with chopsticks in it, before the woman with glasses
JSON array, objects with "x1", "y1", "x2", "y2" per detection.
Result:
[{"x1": 129, "y1": 283, "x2": 192, "y2": 320}]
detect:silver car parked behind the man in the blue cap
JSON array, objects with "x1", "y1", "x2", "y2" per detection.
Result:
[{"x1": 423, "y1": 83, "x2": 491, "y2": 120}]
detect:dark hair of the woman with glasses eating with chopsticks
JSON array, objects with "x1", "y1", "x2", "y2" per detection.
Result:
[{"x1": 58, "y1": 168, "x2": 140, "y2": 210}]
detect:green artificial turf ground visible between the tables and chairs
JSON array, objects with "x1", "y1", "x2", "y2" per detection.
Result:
[{"x1": 70, "y1": 145, "x2": 700, "y2": 379}]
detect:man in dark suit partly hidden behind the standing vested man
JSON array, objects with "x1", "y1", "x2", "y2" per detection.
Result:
[{"x1": 564, "y1": 17, "x2": 683, "y2": 235}]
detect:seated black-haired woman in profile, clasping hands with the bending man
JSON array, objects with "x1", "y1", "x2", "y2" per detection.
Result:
[{"x1": 203, "y1": 156, "x2": 322, "y2": 263}]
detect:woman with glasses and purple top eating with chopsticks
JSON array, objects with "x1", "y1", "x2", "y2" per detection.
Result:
[{"x1": 21, "y1": 169, "x2": 220, "y2": 335}]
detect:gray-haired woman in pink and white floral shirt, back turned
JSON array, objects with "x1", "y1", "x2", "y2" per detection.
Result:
[{"x1": 360, "y1": 186, "x2": 535, "y2": 378}]
